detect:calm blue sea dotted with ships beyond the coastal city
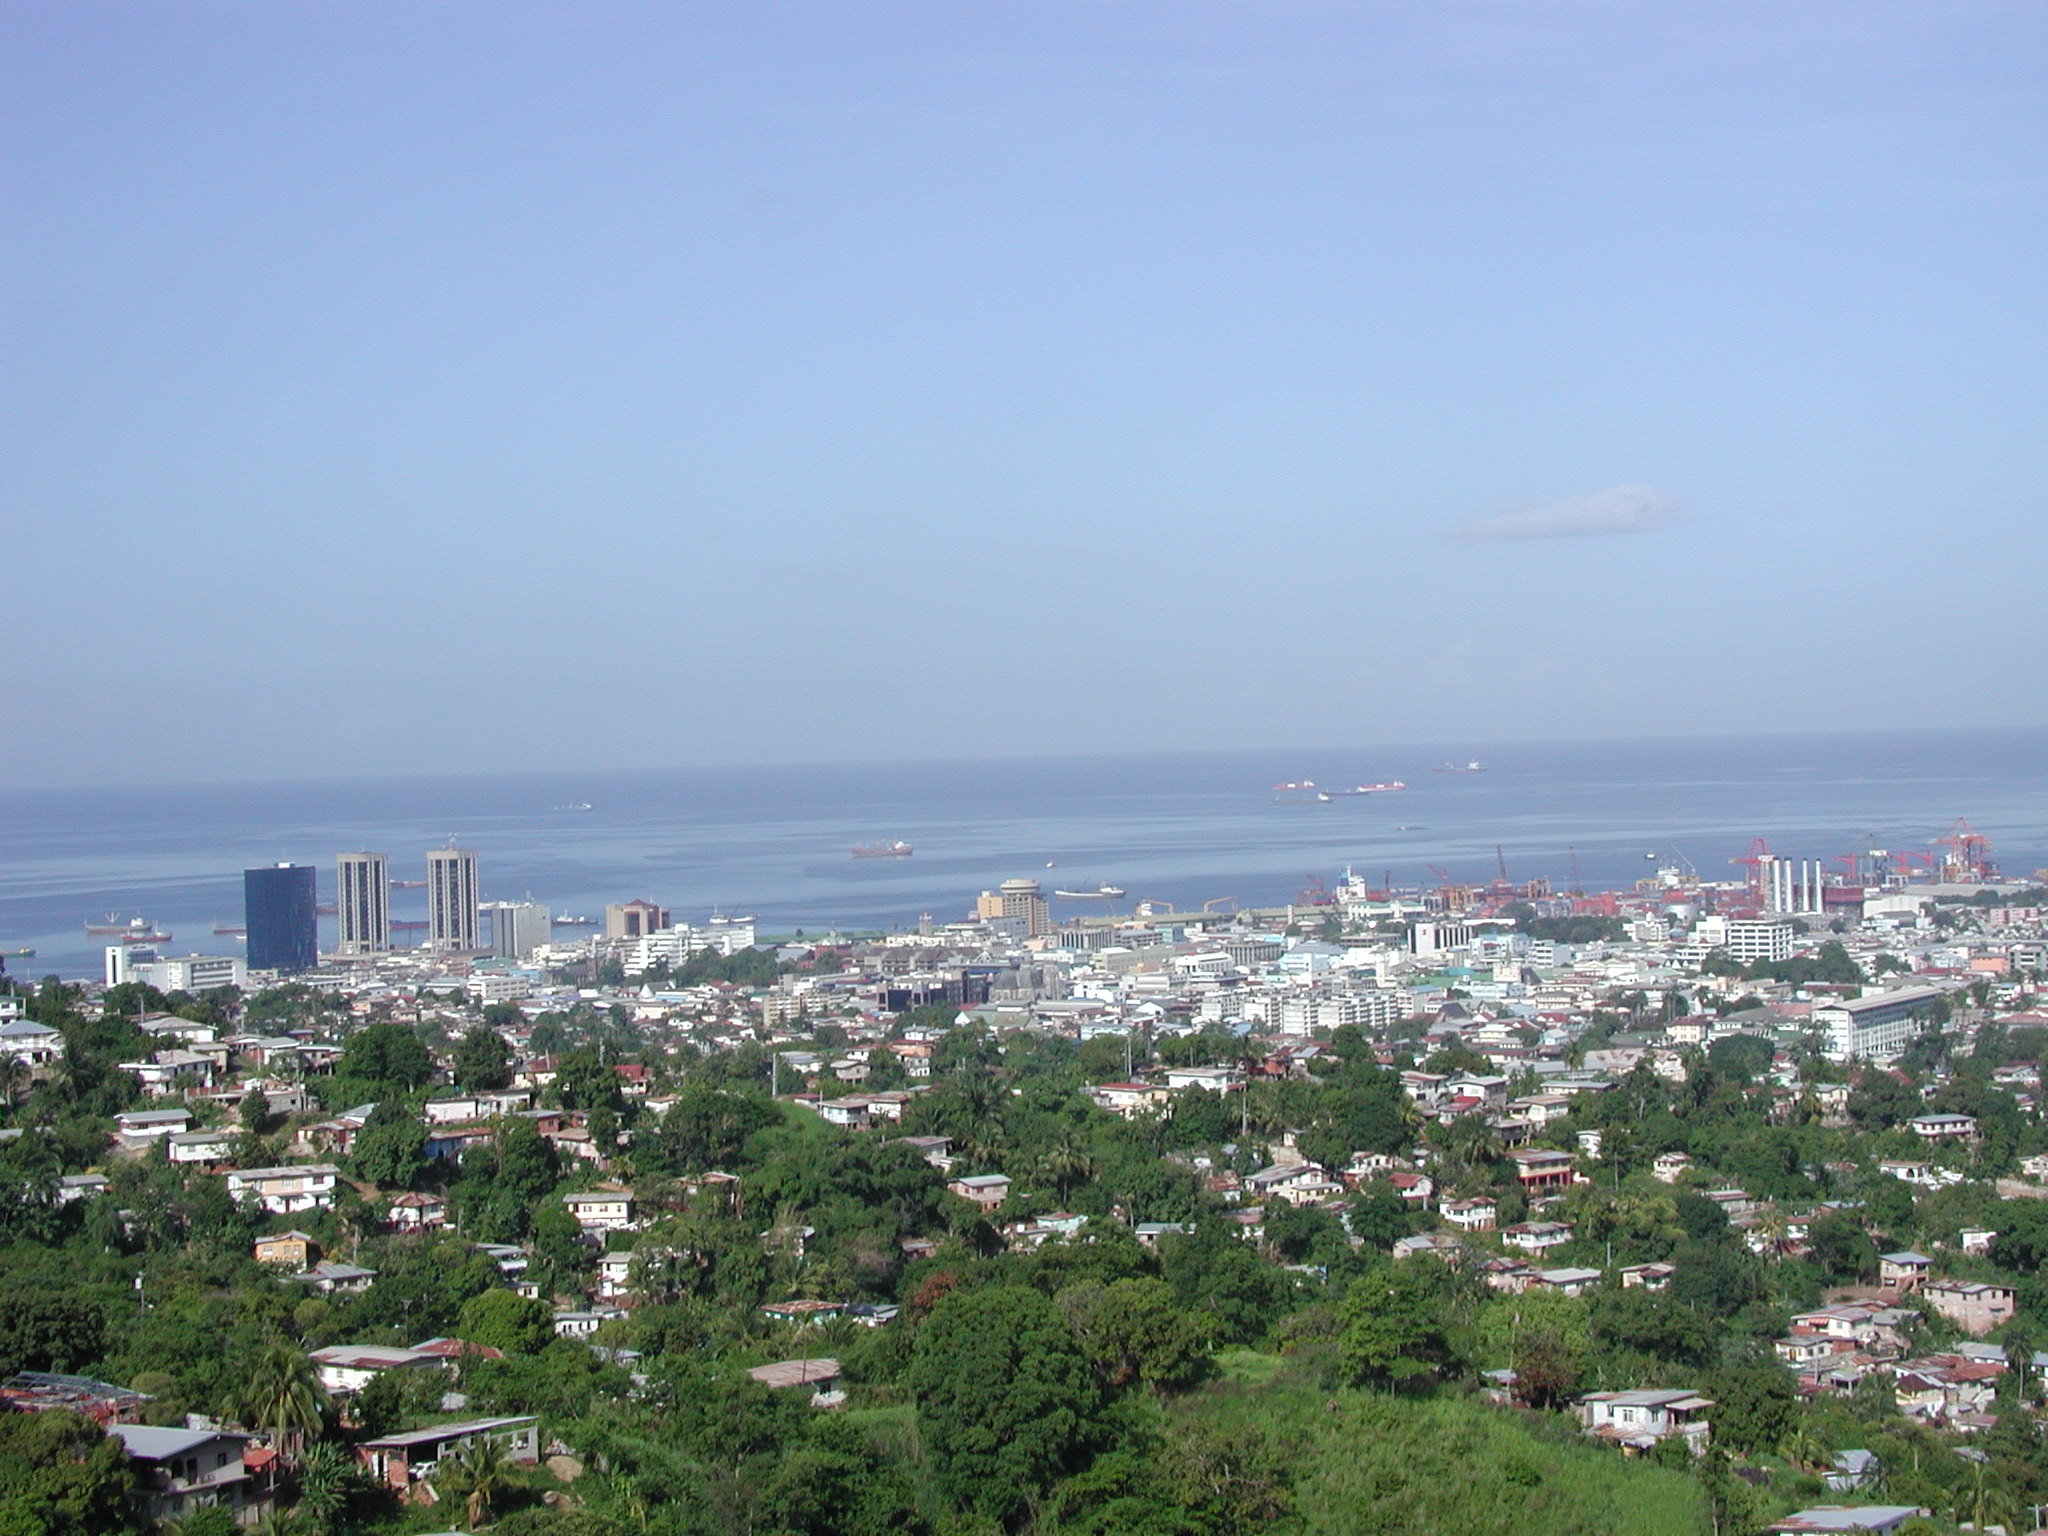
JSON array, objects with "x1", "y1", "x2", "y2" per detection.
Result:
[{"x1": 0, "y1": 731, "x2": 2048, "y2": 977}]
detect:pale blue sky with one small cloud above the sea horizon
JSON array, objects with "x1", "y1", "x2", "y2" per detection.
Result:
[{"x1": 0, "y1": 0, "x2": 2048, "y2": 784}]
